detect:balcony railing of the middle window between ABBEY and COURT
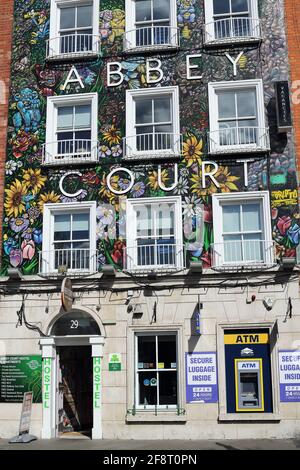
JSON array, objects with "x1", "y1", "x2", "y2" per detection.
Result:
[{"x1": 123, "y1": 132, "x2": 182, "y2": 160}]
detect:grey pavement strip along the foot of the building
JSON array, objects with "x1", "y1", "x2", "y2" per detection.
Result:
[{"x1": 0, "y1": 438, "x2": 300, "y2": 453}]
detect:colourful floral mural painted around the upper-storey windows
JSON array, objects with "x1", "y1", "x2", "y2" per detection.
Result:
[{"x1": 2, "y1": 0, "x2": 300, "y2": 274}]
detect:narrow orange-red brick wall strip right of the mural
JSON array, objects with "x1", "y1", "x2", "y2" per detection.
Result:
[{"x1": 285, "y1": 0, "x2": 300, "y2": 201}]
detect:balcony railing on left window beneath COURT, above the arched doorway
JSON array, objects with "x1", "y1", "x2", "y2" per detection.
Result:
[{"x1": 39, "y1": 248, "x2": 98, "y2": 276}]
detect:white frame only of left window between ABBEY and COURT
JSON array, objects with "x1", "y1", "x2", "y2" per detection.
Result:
[{"x1": 43, "y1": 93, "x2": 98, "y2": 165}]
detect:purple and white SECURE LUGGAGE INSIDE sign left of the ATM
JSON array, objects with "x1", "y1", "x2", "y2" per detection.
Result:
[{"x1": 186, "y1": 352, "x2": 218, "y2": 403}]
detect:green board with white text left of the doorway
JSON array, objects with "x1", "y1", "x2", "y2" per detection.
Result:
[{"x1": 0, "y1": 356, "x2": 42, "y2": 403}]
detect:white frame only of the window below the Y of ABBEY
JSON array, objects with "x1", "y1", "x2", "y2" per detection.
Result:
[{"x1": 208, "y1": 79, "x2": 268, "y2": 154}]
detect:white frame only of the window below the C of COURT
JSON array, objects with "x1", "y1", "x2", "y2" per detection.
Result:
[{"x1": 42, "y1": 201, "x2": 97, "y2": 275}]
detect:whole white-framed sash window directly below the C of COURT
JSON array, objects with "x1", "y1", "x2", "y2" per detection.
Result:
[{"x1": 40, "y1": 202, "x2": 97, "y2": 274}]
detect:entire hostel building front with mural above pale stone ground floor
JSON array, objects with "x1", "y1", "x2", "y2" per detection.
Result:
[{"x1": 0, "y1": 0, "x2": 300, "y2": 439}]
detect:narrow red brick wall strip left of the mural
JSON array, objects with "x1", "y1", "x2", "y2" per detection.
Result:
[{"x1": 0, "y1": 0, "x2": 14, "y2": 256}]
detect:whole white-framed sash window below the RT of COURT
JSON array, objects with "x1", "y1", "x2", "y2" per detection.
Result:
[{"x1": 213, "y1": 191, "x2": 273, "y2": 268}]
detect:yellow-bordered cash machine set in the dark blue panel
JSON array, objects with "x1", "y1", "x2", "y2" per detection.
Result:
[{"x1": 234, "y1": 358, "x2": 265, "y2": 411}]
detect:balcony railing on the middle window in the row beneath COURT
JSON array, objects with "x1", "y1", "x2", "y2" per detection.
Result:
[{"x1": 123, "y1": 241, "x2": 185, "y2": 272}]
